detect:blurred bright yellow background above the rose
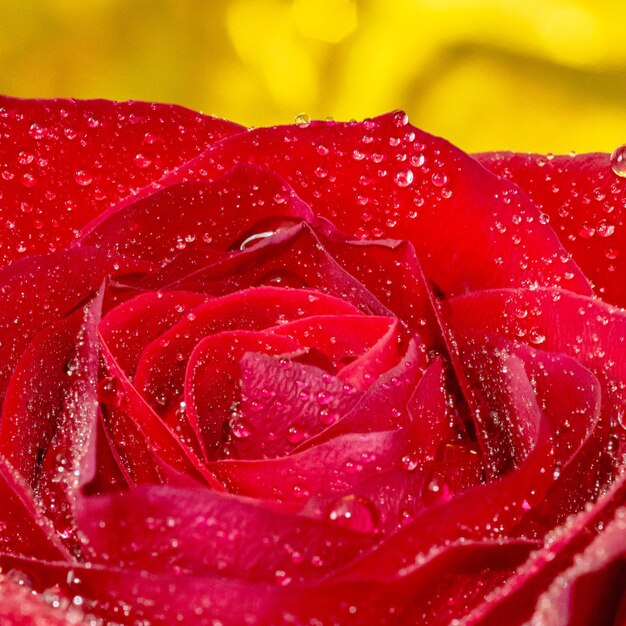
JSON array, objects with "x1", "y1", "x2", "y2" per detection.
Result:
[{"x1": 0, "y1": 0, "x2": 626, "y2": 152}]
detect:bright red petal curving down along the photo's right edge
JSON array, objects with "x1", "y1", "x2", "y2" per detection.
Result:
[{"x1": 448, "y1": 289, "x2": 626, "y2": 502}]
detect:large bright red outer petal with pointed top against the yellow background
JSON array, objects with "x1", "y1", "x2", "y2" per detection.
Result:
[{"x1": 172, "y1": 113, "x2": 590, "y2": 295}]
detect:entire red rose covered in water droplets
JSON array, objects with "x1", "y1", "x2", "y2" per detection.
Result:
[{"x1": 0, "y1": 98, "x2": 626, "y2": 626}]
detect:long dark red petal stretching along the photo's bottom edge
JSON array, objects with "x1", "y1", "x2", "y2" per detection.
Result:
[{"x1": 0, "y1": 540, "x2": 534, "y2": 626}]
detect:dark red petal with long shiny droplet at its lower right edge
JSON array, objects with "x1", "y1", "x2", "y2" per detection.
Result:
[{"x1": 81, "y1": 164, "x2": 314, "y2": 266}]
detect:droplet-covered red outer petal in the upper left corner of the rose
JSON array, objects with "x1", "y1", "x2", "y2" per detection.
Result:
[{"x1": 0, "y1": 97, "x2": 243, "y2": 266}]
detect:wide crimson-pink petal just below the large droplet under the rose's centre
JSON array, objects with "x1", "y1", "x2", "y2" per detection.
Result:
[{"x1": 78, "y1": 486, "x2": 371, "y2": 582}]
